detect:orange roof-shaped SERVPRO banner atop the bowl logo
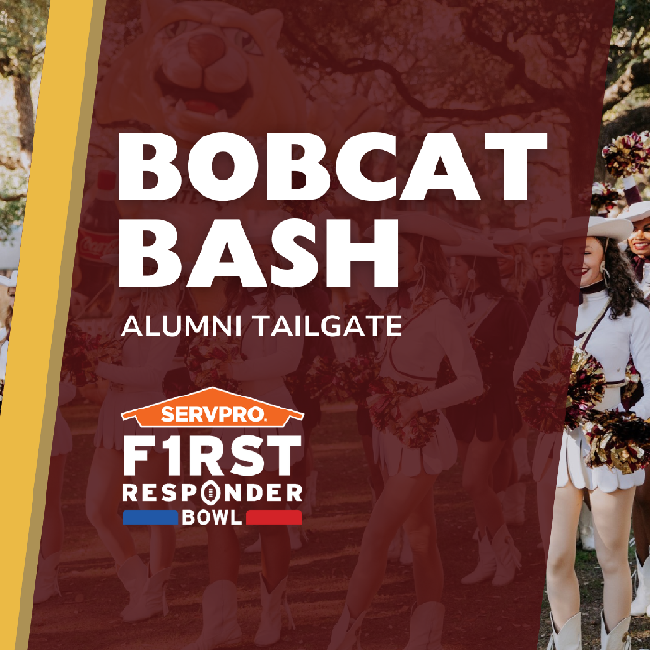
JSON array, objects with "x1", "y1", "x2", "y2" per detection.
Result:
[{"x1": 122, "y1": 388, "x2": 303, "y2": 429}]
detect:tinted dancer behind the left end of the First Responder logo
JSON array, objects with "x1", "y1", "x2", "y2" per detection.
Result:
[{"x1": 86, "y1": 268, "x2": 179, "y2": 622}]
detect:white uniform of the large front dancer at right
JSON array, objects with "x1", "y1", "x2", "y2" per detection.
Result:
[{"x1": 514, "y1": 291, "x2": 650, "y2": 492}]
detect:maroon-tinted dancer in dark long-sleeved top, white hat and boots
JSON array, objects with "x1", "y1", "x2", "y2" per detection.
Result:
[{"x1": 445, "y1": 239, "x2": 528, "y2": 586}]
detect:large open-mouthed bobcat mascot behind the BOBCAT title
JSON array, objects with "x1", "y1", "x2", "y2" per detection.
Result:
[{"x1": 95, "y1": 0, "x2": 384, "y2": 313}]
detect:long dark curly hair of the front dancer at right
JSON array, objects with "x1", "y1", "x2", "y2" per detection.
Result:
[{"x1": 549, "y1": 237, "x2": 648, "y2": 320}]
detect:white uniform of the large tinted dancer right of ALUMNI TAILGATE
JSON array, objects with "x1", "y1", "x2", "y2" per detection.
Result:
[{"x1": 372, "y1": 288, "x2": 483, "y2": 476}]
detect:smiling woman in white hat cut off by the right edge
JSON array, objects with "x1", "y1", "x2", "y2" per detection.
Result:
[{"x1": 621, "y1": 197, "x2": 650, "y2": 616}]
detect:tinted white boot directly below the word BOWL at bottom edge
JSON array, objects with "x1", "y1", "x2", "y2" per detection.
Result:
[{"x1": 184, "y1": 580, "x2": 241, "y2": 650}]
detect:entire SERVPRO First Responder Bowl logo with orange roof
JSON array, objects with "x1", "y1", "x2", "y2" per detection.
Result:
[{"x1": 122, "y1": 388, "x2": 303, "y2": 525}]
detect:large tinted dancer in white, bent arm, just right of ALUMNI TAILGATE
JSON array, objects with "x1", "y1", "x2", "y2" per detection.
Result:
[{"x1": 329, "y1": 212, "x2": 484, "y2": 650}]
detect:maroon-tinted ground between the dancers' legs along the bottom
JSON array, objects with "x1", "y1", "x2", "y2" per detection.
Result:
[{"x1": 24, "y1": 404, "x2": 596, "y2": 650}]
